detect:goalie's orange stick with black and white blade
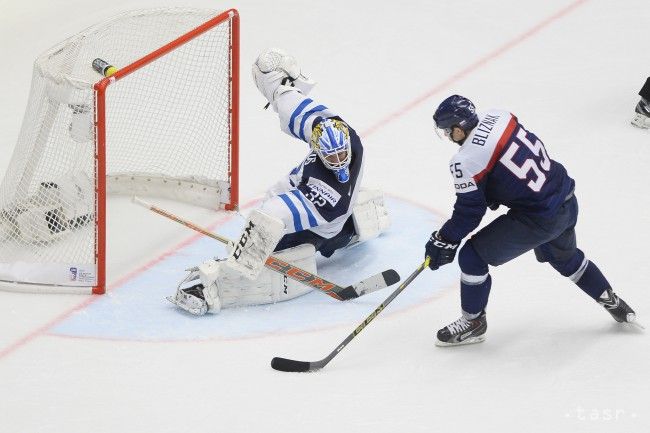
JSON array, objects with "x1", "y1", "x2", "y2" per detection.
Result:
[{"x1": 133, "y1": 196, "x2": 400, "y2": 301}]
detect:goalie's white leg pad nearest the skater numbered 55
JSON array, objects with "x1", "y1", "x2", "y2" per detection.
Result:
[{"x1": 351, "y1": 189, "x2": 390, "y2": 245}]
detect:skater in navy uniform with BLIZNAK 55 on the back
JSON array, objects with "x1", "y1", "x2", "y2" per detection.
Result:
[{"x1": 425, "y1": 95, "x2": 635, "y2": 346}]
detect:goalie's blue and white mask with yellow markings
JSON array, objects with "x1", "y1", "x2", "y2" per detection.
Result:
[{"x1": 311, "y1": 119, "x2": 352, "y2": 183}]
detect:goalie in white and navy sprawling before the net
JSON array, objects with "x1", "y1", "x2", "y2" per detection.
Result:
[{"x1": 168, "y1": 49, "x2": 389, "y2": 315}]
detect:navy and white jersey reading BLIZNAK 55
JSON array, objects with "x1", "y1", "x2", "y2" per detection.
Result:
[{"x1": 440, "y1": 110, "x2": 575, "y2": 242}]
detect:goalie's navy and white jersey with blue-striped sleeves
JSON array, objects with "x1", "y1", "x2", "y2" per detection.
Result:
[{"x1": 262, "y1": 90, "x2": 364, "y2": 239}]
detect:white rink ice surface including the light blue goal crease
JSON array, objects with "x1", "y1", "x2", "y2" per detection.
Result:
[{"x1": 0, "y1": 0, "x2": 650, "y2": 433}]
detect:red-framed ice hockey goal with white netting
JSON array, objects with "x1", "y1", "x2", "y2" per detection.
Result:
[{"x1": 0, "y1": 8, "x2": 239, "y2": 293}]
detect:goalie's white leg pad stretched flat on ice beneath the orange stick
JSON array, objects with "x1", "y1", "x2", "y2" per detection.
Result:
[{"x1": 199, "y1": 244, "x2": 316, "y2": 313}]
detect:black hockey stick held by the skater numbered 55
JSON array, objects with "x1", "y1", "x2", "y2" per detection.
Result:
[{"x1": 271, "y1": 257, "x2": 430, "y2": 373}]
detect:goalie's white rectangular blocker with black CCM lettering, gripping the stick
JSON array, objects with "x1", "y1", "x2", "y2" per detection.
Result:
[{"x1": 226, "y1": 209, "x2": 285, "y2": 280}]
